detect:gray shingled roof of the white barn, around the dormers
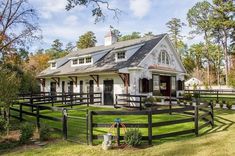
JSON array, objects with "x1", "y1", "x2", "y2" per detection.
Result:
[{"x1": 38, "y1": 34, "x2": 166, "y2": 77}]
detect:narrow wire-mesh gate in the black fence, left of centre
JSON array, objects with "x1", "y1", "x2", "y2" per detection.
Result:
[{"x1": 63, "y1": 108, "x2": 89, "y2": 144}]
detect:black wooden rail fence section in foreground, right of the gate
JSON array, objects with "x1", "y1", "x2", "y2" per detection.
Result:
[{"x1": 89, "y1": 103, "x2": 214, "y2": 145}]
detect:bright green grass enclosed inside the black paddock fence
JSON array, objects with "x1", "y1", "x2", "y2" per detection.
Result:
[{"x1": 11, "y1": 103, "x2": 198, "y2": 144}]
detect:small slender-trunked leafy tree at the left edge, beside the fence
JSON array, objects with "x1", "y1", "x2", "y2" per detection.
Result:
[{"x1": 0, "y1": 67, "x2": 20, "y2": 135}]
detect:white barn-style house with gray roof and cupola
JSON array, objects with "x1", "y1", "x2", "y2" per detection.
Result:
[{"x1": 38, "y1": 32, "x2": 186, "y2": 105}]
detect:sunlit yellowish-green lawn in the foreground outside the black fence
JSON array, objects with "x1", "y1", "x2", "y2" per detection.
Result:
[{"x1": 4, "y1": 108, "x2": 235, "y2": 156}]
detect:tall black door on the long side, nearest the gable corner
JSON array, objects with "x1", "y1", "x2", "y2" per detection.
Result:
[{"x1": 104, "y1": 80, "x2": 113, "y2": 105}]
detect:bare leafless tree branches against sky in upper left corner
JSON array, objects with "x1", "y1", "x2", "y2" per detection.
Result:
[{"x1": 0, "y1": 0, "x2": 40, "y2": 54}]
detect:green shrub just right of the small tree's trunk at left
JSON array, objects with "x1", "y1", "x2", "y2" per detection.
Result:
[{"x1": 20, "y1": 123, "x2": 34, "y2": 144}]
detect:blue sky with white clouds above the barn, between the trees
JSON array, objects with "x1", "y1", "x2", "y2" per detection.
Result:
[{"x1": 29, "y1": 0, "x2": 207, "y2": 51}]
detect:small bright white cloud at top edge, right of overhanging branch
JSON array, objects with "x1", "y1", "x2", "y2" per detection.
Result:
[{"x1": 129, "y1": 0, "x2": 151, "y2": 18}]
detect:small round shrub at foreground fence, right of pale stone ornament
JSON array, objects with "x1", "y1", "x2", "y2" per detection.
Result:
[{"x1": 124, "y1": 129, "x2": 142, "y2": 147}]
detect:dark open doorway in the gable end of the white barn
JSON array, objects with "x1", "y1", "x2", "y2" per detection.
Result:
[{"x1": 160, "y1": 75, "x2": 171, "y2": 96}]
